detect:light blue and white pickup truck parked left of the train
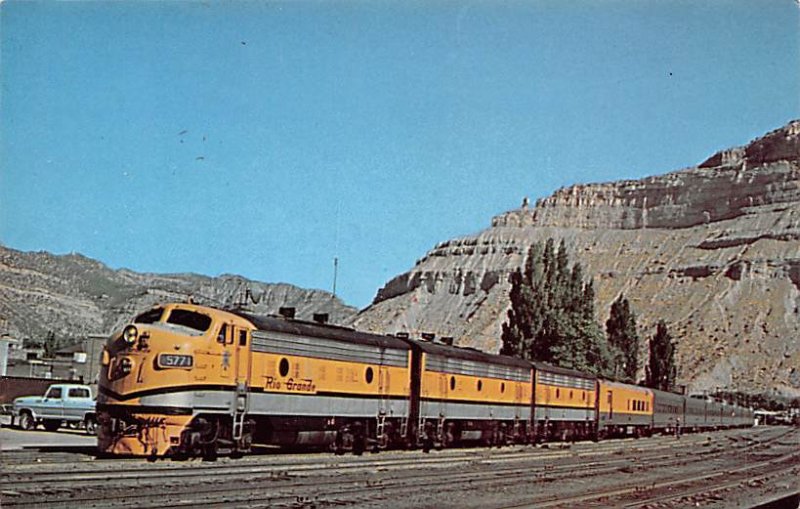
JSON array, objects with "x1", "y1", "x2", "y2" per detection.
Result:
[{"x1": 11, "y1": 384, "x2": 97, "y2": 435}]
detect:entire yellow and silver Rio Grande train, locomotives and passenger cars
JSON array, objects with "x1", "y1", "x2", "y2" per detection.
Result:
[{"x1": 97, "y1": 303, "x2": 753, "y2": 458}]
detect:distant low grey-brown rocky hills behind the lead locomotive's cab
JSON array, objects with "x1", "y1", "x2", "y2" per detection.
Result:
[{"x1": 0, "y1": 247, "x2": 356, "y2": 339}]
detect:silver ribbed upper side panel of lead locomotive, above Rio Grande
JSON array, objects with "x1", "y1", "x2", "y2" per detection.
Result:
[{"x1": 252, "y1": 331, "x2": 408, "y2": 368}]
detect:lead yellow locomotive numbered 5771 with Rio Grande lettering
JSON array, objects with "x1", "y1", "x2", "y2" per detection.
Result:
[{"x1": 97, "y1": 304, "x2": 411, "y2": 458}]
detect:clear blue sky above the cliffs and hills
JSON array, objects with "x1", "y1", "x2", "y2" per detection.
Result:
[{"x1": 0, "y1": 0, "x2": 800, "y2": 307}]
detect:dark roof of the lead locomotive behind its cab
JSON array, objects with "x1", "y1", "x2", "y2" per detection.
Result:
[{"x1": 233, "y1": 311, "x2": 411, "y2": 350}]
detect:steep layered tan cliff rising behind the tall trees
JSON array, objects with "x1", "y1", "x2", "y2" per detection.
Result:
[{"x1": 353, "y1": 121, "x2": 800, "y2": 396}]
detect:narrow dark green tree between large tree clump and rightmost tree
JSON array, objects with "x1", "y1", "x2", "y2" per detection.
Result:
[{"x1": 606, "y1": 295, "x2": 639, "y2": 383}]
